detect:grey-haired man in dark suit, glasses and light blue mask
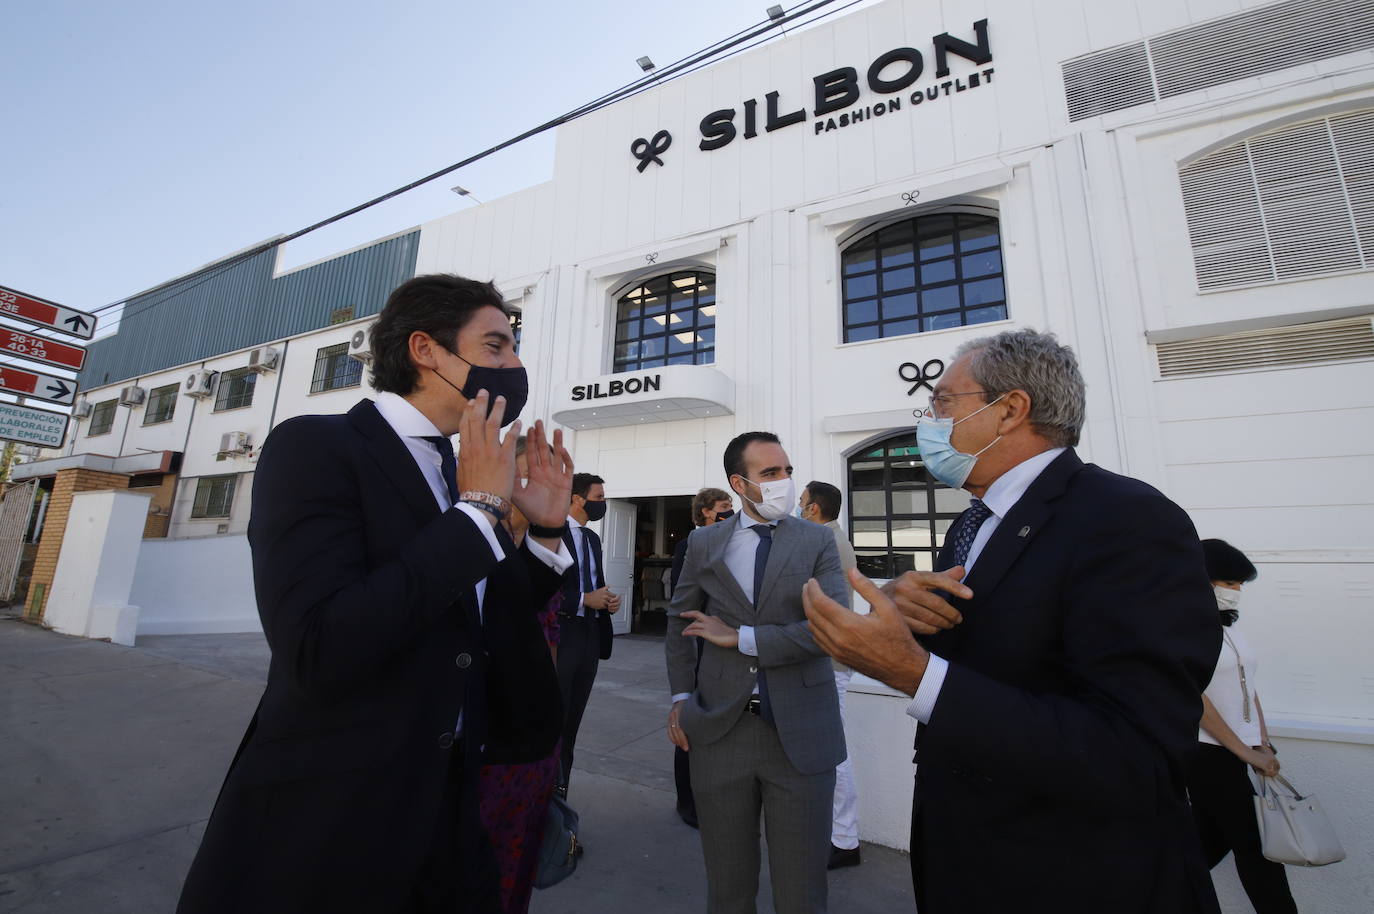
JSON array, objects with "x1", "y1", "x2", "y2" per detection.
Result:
[{"x1": 807, "y1": 330, "x2": 1221, "y2": 914}]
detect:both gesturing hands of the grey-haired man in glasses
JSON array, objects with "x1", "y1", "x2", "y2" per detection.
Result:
[{"x1": 802, "y1": 568, "x2": 973, "y2": 695}]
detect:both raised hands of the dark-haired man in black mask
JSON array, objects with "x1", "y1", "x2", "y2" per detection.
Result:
[{"x1": 458, "y1": 390, "x2": 573, "y2": 526}]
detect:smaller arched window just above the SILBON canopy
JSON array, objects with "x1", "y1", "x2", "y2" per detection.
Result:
[{"x1": 611, "y1": 269, "x2": 716, "y2": 372}]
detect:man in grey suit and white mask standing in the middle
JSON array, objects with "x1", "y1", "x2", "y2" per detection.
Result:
[{"x1": 665, "y1": 432, "x2": 848, "y2": 914}]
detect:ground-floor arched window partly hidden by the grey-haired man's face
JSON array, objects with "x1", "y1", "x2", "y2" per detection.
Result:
[{"x1": 845, "y1": 430, "x2": 969, "y2": 580}]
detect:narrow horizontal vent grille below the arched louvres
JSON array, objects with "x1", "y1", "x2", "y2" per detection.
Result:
[{"x1": 1156, "y1": 317, "x2": 1374, "y2": 378}]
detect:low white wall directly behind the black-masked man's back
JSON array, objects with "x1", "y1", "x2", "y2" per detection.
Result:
[{"x1": 131, "y1": 536, "x2": 262, "y2": 635}]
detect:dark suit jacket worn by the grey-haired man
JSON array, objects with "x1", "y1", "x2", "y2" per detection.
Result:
[{"x1": 911, "y1": 451, "x2": 1221, "y2": 914}]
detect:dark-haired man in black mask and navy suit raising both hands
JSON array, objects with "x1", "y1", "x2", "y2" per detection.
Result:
[{"x1": 177, "y1": 276, "x2": 572, "y2": 914}]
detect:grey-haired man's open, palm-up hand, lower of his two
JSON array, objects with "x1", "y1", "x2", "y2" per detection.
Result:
[{"x1": 802, "y1": 569, "x2": 930, "y2": 695}]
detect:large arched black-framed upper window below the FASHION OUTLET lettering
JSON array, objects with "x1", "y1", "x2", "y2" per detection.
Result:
[{"x1": 842, "y1": 213, "x2": 1007, "y2": 342}]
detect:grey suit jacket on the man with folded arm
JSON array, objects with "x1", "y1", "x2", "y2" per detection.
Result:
[{"x1": 665, "y1": 513, "x2": 849, "y2": 774}]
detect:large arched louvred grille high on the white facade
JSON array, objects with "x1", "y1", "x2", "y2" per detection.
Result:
[{"x1": 1179, "y1": 109, "x2": 1374, "y2": 291}]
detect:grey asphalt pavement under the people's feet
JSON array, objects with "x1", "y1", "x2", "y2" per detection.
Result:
[{"x1": 0, "y1": 617, "x2": 914, "y2": 914}]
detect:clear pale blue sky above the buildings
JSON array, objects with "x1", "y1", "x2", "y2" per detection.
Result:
[{"x1": 0, "y1": 0, "x2": 868, "y2": 335}]
